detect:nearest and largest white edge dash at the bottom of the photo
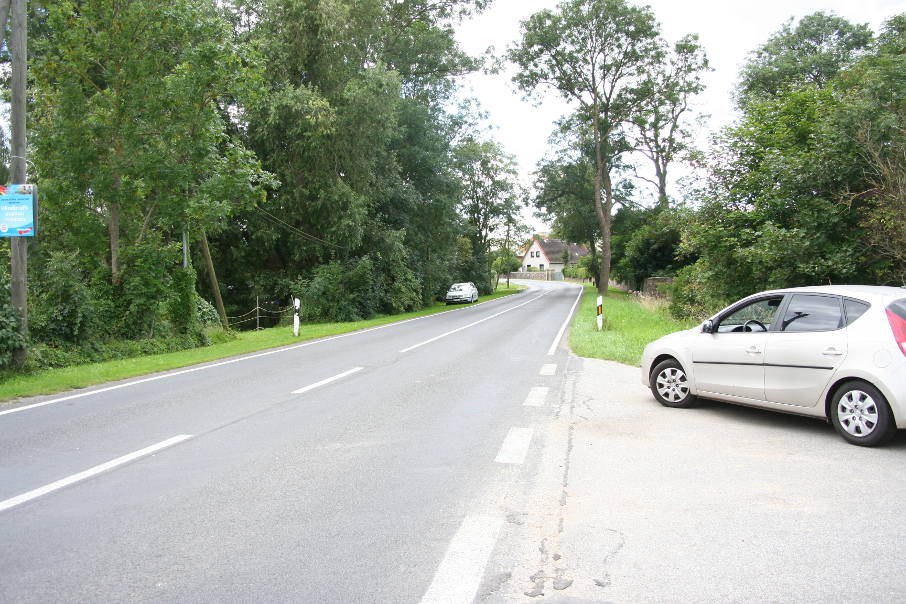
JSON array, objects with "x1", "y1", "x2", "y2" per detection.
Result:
[{"x1": 421, "y1": 516, "x2": 503, "y2": 604}]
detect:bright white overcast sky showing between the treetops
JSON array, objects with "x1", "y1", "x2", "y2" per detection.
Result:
[{"x1": 457, "y1": 0, "x2": 906, "y2": 229}]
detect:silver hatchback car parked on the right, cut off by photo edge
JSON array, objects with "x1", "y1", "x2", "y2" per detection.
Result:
[{"x1": 642, "y1": 285, "x2": 906, "y2": 446}]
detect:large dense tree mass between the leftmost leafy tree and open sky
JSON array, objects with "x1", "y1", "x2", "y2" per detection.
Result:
[{"x1": 212, "y1": 0, "x2": 487, "y2": 312}]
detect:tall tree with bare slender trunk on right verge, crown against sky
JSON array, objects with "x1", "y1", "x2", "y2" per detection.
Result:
[{"x1": 508, "y1": 0, "x2": 665, "y2": 295}]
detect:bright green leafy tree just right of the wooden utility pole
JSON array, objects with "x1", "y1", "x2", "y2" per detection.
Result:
[{"x1": 34, "y1": 0, "x2": 267, "y2": 285}]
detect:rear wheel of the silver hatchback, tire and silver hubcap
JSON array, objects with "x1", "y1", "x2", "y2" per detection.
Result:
[{"x1": 830, "y1": 380, "x2": 897, "y2": 447}]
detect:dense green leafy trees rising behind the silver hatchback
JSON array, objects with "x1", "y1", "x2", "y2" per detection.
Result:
[{"x1": 673, "y1": 13, "x2": 906, "y2": 316}]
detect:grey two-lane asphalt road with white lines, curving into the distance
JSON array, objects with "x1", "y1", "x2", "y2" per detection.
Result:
[{"x1": 0, "y1": 283, "x2": 578, "y2": 604}]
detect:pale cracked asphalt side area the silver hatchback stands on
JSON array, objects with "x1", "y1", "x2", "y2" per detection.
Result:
[{"x1": 484, "y1": 356, "x2": 906, "y2": 604}]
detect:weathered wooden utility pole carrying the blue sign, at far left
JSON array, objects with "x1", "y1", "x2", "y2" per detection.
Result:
[{"x1": 9, "y1": 0, "x2": 28, "y2": 365}]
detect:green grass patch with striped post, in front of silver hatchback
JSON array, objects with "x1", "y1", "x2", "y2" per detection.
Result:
[{"x1": 569, "y1": 285, "x2": 694, "y2": 365}]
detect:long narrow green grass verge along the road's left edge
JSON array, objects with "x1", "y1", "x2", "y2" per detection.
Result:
[{"x1": 0, "y1": 282, "x2": 525, "y2": 401}]
